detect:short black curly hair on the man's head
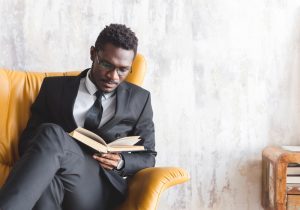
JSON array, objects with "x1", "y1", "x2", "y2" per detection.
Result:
[{"x1": 95, "y1": 24, "x2": 138, "y2": 55}]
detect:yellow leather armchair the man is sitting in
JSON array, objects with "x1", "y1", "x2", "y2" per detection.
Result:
[{"x1": 0, "y1": 55, "x2": 189, "y2": 210}]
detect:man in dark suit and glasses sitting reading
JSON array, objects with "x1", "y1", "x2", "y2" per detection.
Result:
[{"x1": 0, "y1": 24, "x2": 156, "y2": 210}]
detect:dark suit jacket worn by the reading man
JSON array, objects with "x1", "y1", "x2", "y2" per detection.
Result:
[{"x1": 19, "y1": 70, "x2": 156, "y2": 192}]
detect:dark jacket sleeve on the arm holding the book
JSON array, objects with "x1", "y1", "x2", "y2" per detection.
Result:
[{"x1": 121, "y1": 93, "x2": 157, "y2": 176}]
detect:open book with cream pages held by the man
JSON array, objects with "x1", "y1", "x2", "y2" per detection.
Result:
[{"x1": 69, "y1": 127, "x2": 145, "y2": 153}]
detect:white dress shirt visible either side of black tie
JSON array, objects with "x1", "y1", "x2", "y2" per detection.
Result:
[{"x1": 73, "y1": 69, "x2": 116, "y2": 128}]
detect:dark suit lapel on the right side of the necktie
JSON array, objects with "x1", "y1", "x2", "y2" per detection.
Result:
[{"x1": 100, "y1": 82, "x2": 130, "y2": 133}]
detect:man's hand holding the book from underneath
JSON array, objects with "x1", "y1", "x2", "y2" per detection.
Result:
[{"x1": 93, "y1": 153, "x2": 122, "y2": 170}]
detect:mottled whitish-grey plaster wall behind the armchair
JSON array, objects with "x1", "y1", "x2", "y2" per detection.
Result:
[{"x1": 0, "y1": 0, "x2": 300, "y2": 210}]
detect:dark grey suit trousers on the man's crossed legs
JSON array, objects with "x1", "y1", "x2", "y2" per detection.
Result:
[{"x1": 0, "y1": 123, "x2": 123, "y2": 210}]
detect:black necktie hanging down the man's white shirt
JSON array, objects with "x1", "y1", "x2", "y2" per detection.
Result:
[{"x1": 84, "y1": 91, "x2": 103, "y2": 130}]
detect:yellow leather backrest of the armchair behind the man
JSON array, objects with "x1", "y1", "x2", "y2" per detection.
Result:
[{"x1": 0, "y1": 54, "x2": 146, "y2": 187}]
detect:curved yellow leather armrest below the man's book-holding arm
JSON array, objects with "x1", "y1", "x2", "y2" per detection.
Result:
[{"x1": 117, "y1": 167, "x2": 190, "y2": 210}]
